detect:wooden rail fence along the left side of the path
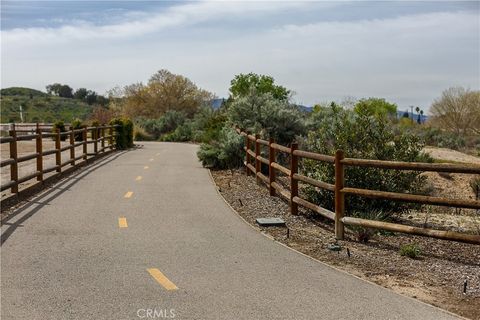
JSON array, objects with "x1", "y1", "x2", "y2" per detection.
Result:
[{"x1": 0, "y1": 126, "x2": 116, "y2": 194}]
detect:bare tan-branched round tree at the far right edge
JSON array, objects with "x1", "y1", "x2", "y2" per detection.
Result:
[{"x1": 430, "y1": 87, "x2": 480, "y2": 135}]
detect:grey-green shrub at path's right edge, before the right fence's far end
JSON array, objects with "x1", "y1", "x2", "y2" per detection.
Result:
[{"x1": 197, "y1": 124, "x2": 244, "y2": 169}]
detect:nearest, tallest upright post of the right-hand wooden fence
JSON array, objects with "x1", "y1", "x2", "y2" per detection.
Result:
[{"x1": 335, "y1": 150, "x2": 345, "y2": 240}]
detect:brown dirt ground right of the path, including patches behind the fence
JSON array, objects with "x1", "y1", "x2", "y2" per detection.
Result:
[{"x1": 212, "y1": 148, "x2": 480, "y2": 319}]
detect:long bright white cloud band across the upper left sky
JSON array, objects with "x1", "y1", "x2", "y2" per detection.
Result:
[{"x1": 2, "y1": 1, "x2": 312, "y2": 46}]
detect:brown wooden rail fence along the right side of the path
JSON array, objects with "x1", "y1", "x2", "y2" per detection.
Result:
[{"x1": 236, "y1": 128, "x2": 480, "y2": 244}]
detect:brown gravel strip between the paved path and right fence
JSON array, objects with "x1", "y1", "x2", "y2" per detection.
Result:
[{"x1": 212, "y1": 170, "x2": 480, "y2": 319}]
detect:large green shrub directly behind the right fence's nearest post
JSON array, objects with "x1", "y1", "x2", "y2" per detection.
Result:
[{"x1": 301, "y1": 105, "x2": 431, "y2": 215}]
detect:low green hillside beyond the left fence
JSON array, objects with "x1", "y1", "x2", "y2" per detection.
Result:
[{"x1": 0, "y1": 87, "x2": 92, "y2": 123}]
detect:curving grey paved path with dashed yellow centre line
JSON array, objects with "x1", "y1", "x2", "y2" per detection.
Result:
[{"x1": 1, "y1": 143, "x2": 462, "y2": 320}]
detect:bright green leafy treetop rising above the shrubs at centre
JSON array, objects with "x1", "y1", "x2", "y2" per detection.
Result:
[{"x1": 230, "y1": 73, "x2": 291, "y2": 101}]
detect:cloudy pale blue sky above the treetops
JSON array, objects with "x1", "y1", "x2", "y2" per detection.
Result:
[{"x1": 1, "y1": 0, "x2": 480, "y2": 110}]
